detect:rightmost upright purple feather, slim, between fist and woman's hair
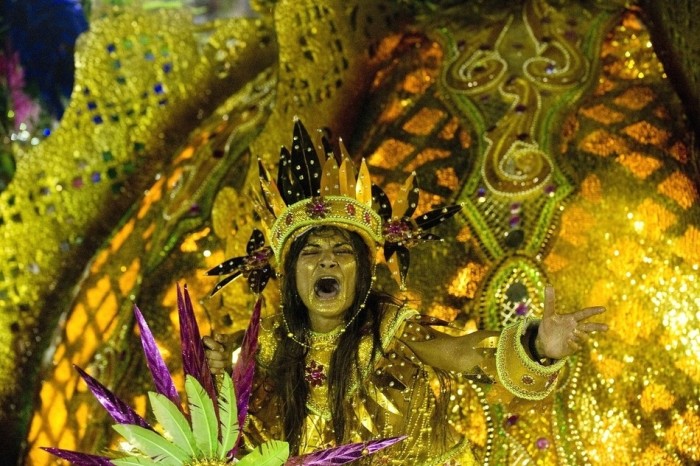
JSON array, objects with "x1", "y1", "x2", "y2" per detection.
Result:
[{"x1": 231, "y1": 298, "x2": 262, "y2": 455}]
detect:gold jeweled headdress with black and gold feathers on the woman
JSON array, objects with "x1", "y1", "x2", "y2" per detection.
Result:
[{"x1": 207, "y1": 118, "x2": 461, "y2": 294}]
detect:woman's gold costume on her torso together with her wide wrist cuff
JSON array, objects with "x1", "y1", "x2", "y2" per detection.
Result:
[{"x1": 246, "y1": 306, "x2": 561, "y2": 465}]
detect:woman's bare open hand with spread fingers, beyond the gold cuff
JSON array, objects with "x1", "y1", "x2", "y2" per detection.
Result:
[{"x1": 535, "y1": 285, "x2": 608, "y2": 359}]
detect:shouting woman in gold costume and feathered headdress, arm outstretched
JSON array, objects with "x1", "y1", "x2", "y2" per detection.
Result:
[{"x1": 204, "y1": 122, "x2": 606, "y2": 465}]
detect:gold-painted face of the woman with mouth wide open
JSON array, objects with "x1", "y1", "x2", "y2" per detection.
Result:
[{"x1": 296, "y1": 230, "x2": 357, "y2": 332}]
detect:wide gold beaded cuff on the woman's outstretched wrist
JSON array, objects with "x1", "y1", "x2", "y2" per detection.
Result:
[{"x1": 496, "y1": 319, "x2": 566, "y2": 400}]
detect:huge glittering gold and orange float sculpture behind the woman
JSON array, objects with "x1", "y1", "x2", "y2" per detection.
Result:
[{"x1": 0, "y1": 0, "x2": 700, "y2": 464}]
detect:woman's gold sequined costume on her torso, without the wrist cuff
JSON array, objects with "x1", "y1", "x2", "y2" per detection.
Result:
[{"x1": 246, "y1": 306, "x2": 476, "y2": 465}]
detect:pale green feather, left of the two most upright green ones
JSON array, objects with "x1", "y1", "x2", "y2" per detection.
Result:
[{"x1": 185, "y1": 375, "x2": 219, "y2": 458}]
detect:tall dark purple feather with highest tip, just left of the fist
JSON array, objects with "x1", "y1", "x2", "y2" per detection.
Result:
[{"x1": 177, "y1": 285, "x2": 219, "y2": 418}]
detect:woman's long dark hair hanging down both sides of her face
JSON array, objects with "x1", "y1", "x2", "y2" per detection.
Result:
[{"x1": 271, "y1": 227, "x2": 396, "y2": 454}]
